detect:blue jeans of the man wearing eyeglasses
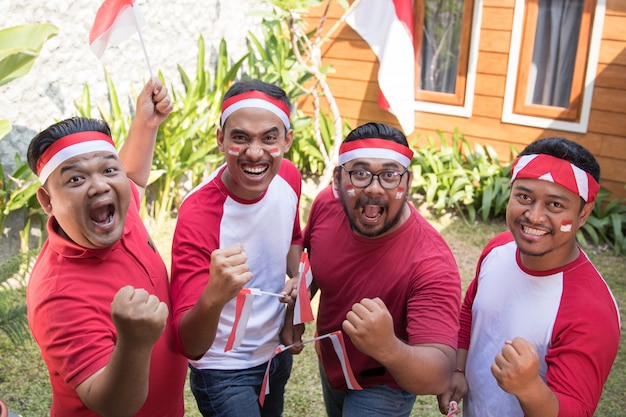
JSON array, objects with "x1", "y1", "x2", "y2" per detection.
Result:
[{"x1": 320, "y1": 365, "x2": 415, "y2": 417}]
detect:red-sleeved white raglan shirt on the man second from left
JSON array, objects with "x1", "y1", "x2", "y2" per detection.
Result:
[{"x1": 171, "y1": 159, "x2": 302, "y2": 370}]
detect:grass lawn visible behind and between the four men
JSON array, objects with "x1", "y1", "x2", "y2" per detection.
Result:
[{"x1": 0, "y1": 210, "x2": 626, "y2": 417}]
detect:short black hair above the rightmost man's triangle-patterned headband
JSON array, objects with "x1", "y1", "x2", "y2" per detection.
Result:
[{"x1": 518, "y1": 137, "x2": 600, "y2": 182}]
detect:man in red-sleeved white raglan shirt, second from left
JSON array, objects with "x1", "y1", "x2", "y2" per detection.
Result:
[{"x1": 171, "y1": 80, "x2": 302, "y2": 417}]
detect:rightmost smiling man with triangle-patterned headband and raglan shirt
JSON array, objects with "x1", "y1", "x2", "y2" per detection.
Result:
[{"x1": 440, "y1": 138, "x2": 620, "y2": 417}]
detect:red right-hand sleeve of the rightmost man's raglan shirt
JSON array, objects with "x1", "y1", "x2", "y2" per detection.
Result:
[{"x1": 545, "y1": 262, "x2": 620, "y2": 417}]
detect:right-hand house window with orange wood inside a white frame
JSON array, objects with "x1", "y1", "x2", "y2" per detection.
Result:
[{"x1": 502, "y1": 0, "x2": 604, "y2": 132}]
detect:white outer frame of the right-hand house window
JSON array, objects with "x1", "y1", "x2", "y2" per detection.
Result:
[{"x1": 502, "y1": 0, "x2": 606, "y2": 133}]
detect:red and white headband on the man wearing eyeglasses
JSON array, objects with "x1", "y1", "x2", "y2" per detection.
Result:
[{"x1": 339, "y1": 138, "x2": 413, "y2": 168}]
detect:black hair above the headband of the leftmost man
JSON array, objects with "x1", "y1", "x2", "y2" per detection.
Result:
[{"x1": 27, "y1": 116, "x2": 111, "y2": 175}]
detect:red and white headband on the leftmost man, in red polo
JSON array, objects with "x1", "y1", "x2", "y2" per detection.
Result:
[{"x1": 37, "y1": 131, "x2": 117, "y2": 184}]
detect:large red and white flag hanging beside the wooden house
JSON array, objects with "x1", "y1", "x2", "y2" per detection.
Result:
[{"x1": 346, "y1": 0, "x2": 415, "y2": 135}]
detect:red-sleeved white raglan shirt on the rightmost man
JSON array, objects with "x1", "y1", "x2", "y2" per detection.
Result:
[{"x1": 459, "y1": 232, "x2": 620, "y2": 417}]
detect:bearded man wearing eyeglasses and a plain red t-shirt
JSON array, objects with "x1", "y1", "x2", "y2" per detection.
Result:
[{"x1": 304, "y1": 123, "x2": 461, "y2": 417}]
